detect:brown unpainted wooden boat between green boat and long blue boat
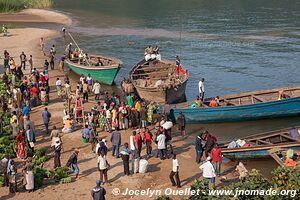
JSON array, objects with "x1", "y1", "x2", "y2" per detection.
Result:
[{"x1": 129, "y1": 60, "x2": 188, "y2": 104}]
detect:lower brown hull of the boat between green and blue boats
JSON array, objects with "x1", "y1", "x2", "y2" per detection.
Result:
[{"x1": 135, "y1": 81, "x2": 187, "y2": 104}]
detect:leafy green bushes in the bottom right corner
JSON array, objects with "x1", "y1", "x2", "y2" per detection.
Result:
[{"x1": 189, "y1": 166, "x2": 300, "y2": 200}]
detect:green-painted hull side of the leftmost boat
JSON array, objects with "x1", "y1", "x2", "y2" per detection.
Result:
[{"x1": 66, "y1": 61, "x2": 120, "y2": 85}]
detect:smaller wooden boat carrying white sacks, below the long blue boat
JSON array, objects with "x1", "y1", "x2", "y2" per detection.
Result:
[{"x1": 220, "y1": 127, "x2": 300, "y2": 160}]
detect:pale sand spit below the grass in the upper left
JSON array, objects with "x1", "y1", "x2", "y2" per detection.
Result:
[{"x1": 0, "y1": 9, "x2": 72, "y2": 26}]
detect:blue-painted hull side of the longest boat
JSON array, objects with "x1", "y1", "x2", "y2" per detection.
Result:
[{"x1": 171, "y1": 97, "x2": 300, "y2": 123}]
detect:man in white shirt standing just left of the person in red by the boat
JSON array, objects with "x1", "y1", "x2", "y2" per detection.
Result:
[{"x1": 199, "y1": 156, "x2": 216, "y2": 190}]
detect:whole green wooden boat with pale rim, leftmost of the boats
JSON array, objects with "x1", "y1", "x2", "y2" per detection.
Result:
[{"x1": 66, "y1": 55, "x2": 122, "y2": 85}]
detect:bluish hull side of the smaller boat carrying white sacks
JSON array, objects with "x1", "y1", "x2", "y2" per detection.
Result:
[{"x1": 222, "y1": 143, "x2": 300, "y2": 160}]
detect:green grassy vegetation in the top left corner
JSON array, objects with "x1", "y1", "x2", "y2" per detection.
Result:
[{"x1": 0, "y1": 0, "x2": 53, "y2": 12}]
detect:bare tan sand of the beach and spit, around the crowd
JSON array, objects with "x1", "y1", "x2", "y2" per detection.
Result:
[{"x1": 0, "y1": 9, "x2": 236, "y2": 200}]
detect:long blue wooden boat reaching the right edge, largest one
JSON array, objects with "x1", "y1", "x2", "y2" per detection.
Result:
[{"x1": 171, "y1": 86, "x2": 300, "y2": 123}]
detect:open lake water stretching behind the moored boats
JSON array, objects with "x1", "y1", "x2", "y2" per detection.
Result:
[{"x1": 56, "y1": 0, "x2": 300, "y2": 99}]
